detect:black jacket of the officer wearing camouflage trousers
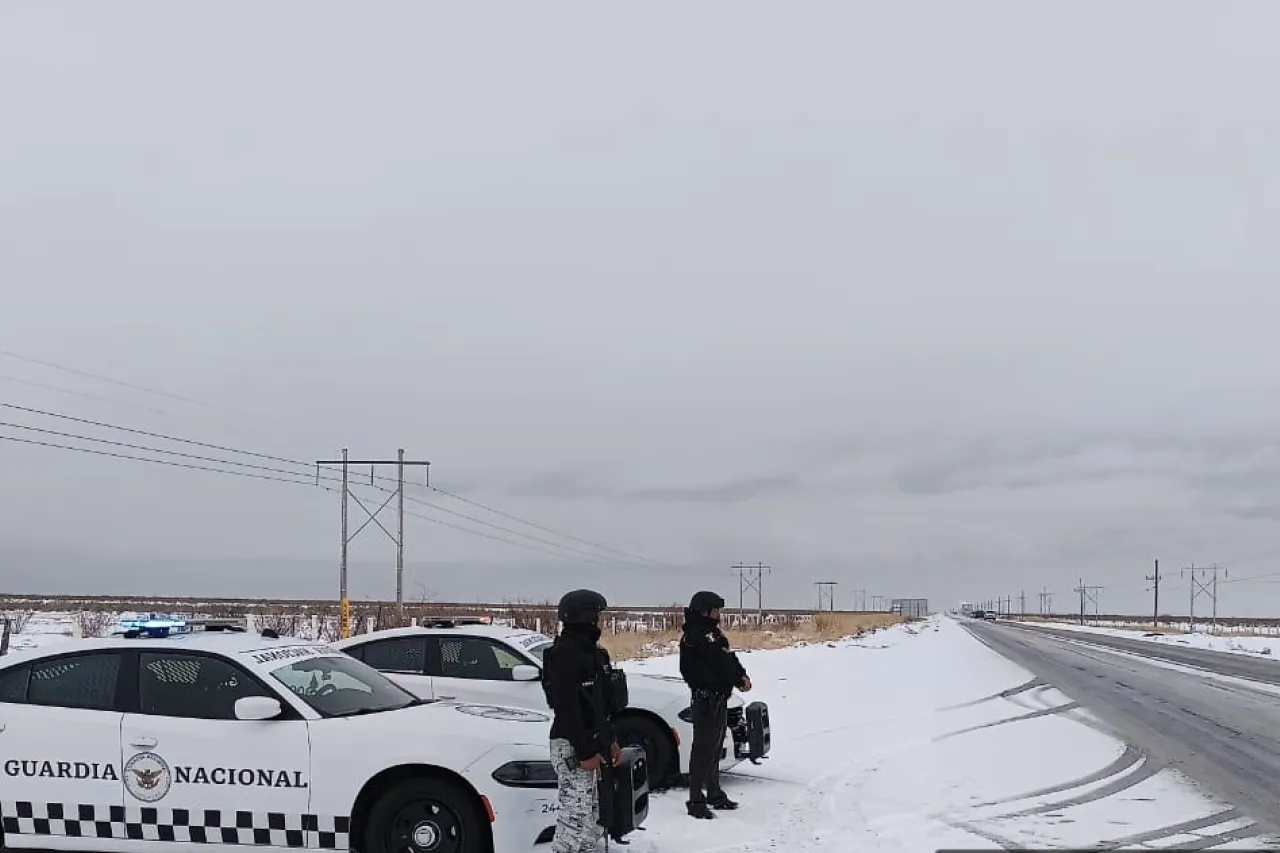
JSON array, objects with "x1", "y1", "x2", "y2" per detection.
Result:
[{"x1": 543, "y1": 625, "x2": 613, "y2": 760}]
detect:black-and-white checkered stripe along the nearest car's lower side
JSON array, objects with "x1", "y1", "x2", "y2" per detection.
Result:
[{"x1": 0, "y1": 802, "x2": 351, "y2": 850}]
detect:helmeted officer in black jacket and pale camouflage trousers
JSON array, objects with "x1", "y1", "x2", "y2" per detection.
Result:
[{"x1": 543, "y1": 589, "x2": 622, "y2": 853}]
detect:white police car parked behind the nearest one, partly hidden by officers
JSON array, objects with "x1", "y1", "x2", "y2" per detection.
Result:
[{"x1": 333, "y1": 620, "x2": 771, "y2": 788}]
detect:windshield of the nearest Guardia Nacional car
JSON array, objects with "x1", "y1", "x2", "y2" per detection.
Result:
[{"x1": 271, "y1": 654, "x2": 422, "y2": 717}]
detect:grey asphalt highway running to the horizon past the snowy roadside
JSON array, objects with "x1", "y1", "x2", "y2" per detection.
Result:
[{"x1": 961, "y1": 620, "x2": 1280, "y2": 836}]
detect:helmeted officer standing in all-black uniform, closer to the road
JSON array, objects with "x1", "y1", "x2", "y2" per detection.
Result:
[{"x1": 680, "y1": 590, "x2": 751, "y2": 818}]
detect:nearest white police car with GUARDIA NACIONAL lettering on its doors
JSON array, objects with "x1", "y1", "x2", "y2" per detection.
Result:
[{"x1": 0, "y1": 622, "x2": 556, "y2": 853}]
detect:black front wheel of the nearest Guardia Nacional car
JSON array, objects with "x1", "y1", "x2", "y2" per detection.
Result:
[{"x1": 361, "y1": 777, "x2": 489, "y2": 853}]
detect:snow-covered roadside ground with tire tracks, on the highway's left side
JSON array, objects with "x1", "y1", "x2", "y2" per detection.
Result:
[{"x1": 0, "y1": 613, "x2": 1258, "y2": 853}]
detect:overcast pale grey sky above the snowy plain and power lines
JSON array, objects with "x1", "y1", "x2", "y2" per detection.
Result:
[{"x1": 0, "y1": 0, "x2": 1280, "y2": 613}]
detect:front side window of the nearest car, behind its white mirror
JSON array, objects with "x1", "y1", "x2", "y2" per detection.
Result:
[{"x1": 138, "y1": 652, "x2": 279, "y2": 720}]
